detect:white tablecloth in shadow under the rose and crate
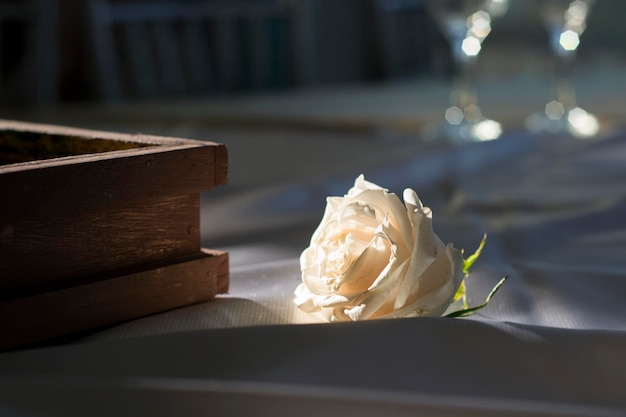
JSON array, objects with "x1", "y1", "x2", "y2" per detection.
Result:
[{"x1": 0, "y1": 128, "x2": 626, "y2": 416}]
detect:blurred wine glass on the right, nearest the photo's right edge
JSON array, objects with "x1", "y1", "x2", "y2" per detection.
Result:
[{"x1": 526, "y1": 0, "x2": 599, "y2": 138}]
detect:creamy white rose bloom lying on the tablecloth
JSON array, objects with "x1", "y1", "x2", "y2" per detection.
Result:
[{"x1": 294, "y1": 175, "x2": 464, "y2": 321}]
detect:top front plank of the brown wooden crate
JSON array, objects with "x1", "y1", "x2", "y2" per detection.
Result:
[{"x1": 0, "y1": 138, "x2": 227, "y2": 222}]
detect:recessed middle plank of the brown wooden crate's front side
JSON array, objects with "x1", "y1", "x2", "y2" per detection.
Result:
[{"x1": 0, "y1": 194, "x2": 200, "y2": 294}]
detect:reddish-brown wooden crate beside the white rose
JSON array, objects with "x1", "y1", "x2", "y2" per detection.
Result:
[{"x1": 0, "y1": 120, "x2": 228, "y2": 350}]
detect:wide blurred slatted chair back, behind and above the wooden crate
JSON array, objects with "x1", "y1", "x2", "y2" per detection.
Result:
[{"x1": 86, "y1": 0, "x2": 294, "y2": 101}]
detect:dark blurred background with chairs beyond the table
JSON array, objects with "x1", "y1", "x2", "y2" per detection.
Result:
[{"x1": 0, "y1": 0, "x2": 626, "y2": 108}]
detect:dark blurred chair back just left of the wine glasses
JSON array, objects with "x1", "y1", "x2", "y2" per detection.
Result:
[{"x1": 373, "y1": 0, "x2": 448, "y2": 79}]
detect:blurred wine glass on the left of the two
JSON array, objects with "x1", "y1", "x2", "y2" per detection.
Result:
[{"x1": 424, "y1": 0, "x2": 508, "y2": 144}]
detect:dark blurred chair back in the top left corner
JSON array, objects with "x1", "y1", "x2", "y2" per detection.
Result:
[{"x1": 0, "y1": 0, "x2": 59, "y2": 104}]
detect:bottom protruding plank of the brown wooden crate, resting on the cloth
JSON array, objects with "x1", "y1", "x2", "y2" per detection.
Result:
[{"x1": 0, "y1": 250, "x2": 228, "y2": 350}]
